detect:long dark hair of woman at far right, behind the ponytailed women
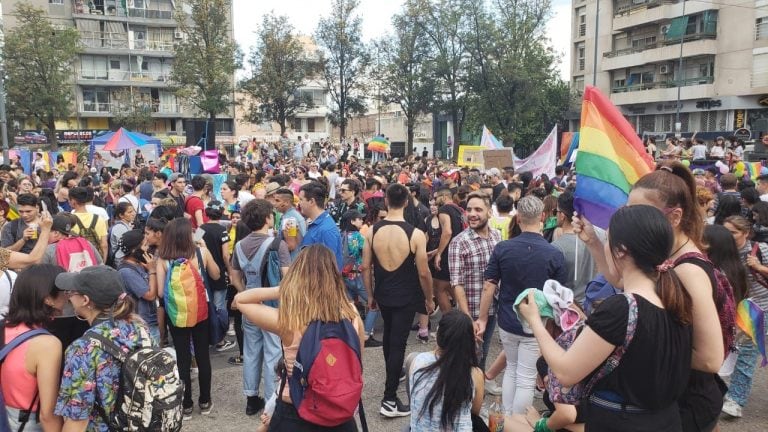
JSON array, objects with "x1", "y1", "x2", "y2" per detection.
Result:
[{"x1": 704, "y1": 225, "x2": 749, "y2": 304}]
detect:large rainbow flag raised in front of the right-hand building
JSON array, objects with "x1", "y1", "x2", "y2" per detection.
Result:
[{"x1": 574, "y1": 86, "x2": 654, "y2": 228}]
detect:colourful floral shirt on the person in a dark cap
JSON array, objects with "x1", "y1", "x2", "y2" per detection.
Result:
[{"x1": 54, "y1": 320, "x2": 151, "y2": 432}]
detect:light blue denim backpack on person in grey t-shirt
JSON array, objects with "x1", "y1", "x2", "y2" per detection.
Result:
[{"x1": 235, "y1": 237, "x2": 282, "y2": 307}]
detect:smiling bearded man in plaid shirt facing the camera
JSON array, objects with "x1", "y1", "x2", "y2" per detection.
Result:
[{"x1": 448, "y1": 192, "x2": 501, "y2": 370}]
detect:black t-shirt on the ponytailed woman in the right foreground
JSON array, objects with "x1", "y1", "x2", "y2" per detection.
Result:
[{"x1": 587, "y1": 295, "x2": 692, "y2": 410}]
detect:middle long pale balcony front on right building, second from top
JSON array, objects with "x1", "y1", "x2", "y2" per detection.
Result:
[{"x1": 601, "y1": 35, "x2": 718, "y2": 71}]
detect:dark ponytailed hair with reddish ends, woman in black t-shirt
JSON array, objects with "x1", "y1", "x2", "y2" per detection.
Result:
[{"x1": 608, "y1": 205, "x2": 692, "y2": 324}]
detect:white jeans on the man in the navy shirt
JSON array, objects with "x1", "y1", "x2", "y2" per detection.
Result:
[{"x1": 499, "y1": 328, "x2": 539, "y2": 415}]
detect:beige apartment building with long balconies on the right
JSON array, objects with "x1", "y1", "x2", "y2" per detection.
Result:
[{"x1": 571, "y1": 0, "x2": 768, "y2": 138}]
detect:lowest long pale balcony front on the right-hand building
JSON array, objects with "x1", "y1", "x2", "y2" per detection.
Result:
[{"x1": 611, "y1": 77, "x2": 715, "y2": 105}]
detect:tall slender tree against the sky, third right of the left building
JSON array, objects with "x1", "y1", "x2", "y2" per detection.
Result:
[{"x1": 315, "y1": 0, "x2": 370, "y2": 139}]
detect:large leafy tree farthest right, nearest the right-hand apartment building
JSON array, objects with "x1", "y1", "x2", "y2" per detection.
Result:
[{"x1": 467, "y1": 0, "x2": 570, "y2": 150}]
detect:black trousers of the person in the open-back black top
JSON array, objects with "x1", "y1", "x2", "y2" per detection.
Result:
[{"x1": 379, "y1": 305, "x2": 416, "y2": 400}]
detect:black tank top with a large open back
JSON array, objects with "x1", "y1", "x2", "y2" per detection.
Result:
[{"x1": 371, "y1": 220, "x2": 424, "y2": 307}]
